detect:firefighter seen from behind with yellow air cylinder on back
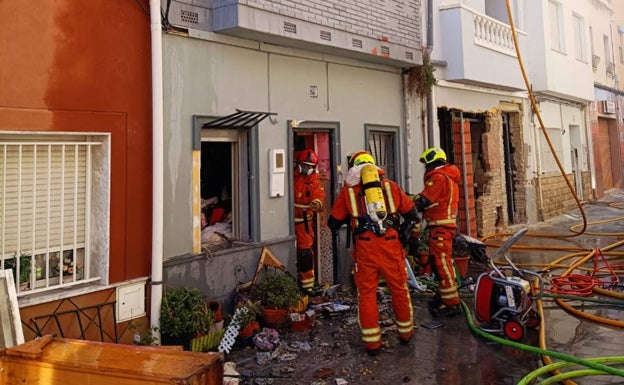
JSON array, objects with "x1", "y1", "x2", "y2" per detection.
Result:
[{"x1": 327, "y1": 151, "x2": 419, "y2": 355}]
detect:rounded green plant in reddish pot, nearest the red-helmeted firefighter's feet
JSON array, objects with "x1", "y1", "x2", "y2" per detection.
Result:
[{"x1": 254, "y1": 271, "x2": 301, "y2": 328}]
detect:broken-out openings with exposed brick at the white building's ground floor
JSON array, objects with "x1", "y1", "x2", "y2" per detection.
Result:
[{"x1": 438, "y1": 105, "x2": 526, "y2": 237}]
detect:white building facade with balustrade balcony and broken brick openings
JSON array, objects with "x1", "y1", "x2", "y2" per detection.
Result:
[{"x1": 428, "y1": 0, "x2": 593, "y2": 236}]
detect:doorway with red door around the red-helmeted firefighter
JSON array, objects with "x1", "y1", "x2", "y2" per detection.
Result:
[{"x1": 289, "y1": 120, "x2": 338, "y2": 285}]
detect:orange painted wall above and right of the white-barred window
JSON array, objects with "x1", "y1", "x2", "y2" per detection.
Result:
[{"x1": 0, "y1": 0, "x2": 152, "y2": 283}]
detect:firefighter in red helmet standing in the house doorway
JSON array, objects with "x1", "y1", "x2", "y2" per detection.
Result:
[{"x1": 294, "y1": 149, "x2": 325, "y2": 292}]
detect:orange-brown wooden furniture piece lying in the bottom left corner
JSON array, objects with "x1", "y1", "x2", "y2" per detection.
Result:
[{"x1": 0, "y1": 336, "x2": 224, "y2": 385}]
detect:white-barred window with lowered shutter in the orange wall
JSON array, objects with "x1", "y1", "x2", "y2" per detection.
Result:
[{"x1": 0, "y1": 134, "x2": 109, "y2": 295}]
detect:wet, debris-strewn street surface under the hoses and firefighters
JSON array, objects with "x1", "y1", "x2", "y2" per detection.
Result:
[{"x1": 226, "y1": 190, "x2": 624, "y2": 385}]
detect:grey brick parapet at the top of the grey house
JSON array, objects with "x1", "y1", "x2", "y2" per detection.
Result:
[{"x1": 241, "y1": 0, "x2": 422, "y2": 48}]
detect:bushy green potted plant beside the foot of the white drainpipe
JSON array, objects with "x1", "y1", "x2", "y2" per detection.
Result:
[{"x1": 160, "y1": 287, "x2": 215, "y2": 350}]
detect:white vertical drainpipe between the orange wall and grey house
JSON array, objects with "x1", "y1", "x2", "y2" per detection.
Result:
[{"x1": 150, "y1": 0, "x2": 164, "y2": 337}]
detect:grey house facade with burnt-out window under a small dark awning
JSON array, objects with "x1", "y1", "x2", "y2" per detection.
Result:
[{"x1": 158, "y1": 0, "x2": 424, "y2": 298}]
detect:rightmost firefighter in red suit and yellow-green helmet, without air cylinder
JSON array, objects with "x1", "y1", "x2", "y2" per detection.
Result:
[{"x1": 413, "y1": 147, "x2": 461, "y2": 317}]
